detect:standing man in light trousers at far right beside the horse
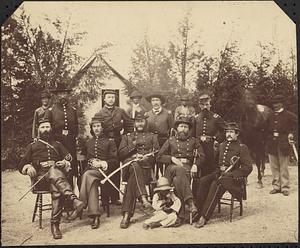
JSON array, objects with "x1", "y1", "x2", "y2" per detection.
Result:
[{"x1": 266, "y1": 95, "x2": 297, "y2": 196}]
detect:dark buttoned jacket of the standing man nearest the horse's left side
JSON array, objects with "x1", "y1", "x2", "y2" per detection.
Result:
[{"x1": 193, "y1": 111, "x2": 225, "y2": 142}]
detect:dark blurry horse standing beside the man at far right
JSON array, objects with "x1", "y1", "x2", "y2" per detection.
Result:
[{"x1": 240, "y1": 91, "x2": 272, "y2": 188}]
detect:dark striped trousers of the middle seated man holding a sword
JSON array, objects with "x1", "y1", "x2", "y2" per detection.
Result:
[{"x1": 122, "y1": 162, "x2": 149, "y2": 216}]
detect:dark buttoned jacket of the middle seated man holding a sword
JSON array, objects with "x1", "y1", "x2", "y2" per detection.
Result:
[{"x1": 119, "y1": 131, "x2": 159, "y2": 168}]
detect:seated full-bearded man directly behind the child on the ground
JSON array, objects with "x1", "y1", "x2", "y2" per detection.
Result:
[{"x1": 157, "y1": 117, "x2": 205, "y2": 227}]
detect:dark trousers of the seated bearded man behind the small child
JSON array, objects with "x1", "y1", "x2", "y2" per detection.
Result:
[{"x1": 165, "y1": 164, "x2": 193, "y2": 218}]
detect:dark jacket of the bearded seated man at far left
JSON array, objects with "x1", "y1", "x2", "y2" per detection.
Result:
[{"x1": 18, "y1": 140, "x2": 72, "y2": 172}]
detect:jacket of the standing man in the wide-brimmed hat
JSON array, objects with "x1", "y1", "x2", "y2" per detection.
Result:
[{"x1": 146, "y1": 108, "x2": 173, "y2": 137}]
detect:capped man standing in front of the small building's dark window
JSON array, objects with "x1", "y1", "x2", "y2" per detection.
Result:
[{"x1": 97, "y1": 90, "x2": 133, "y2": 205}]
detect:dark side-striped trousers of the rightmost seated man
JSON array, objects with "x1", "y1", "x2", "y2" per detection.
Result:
[{"x1": 200, "y1": 176, "x2": 243, "y2": 221}]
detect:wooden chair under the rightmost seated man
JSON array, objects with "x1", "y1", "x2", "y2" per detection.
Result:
[{"x1": 218, "y1": 178, "x2": 247, "y2": 222}]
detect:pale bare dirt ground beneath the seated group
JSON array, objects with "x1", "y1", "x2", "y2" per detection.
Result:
[{"x1": 1, "y1": 165, "x2": 298, "y2": 245}]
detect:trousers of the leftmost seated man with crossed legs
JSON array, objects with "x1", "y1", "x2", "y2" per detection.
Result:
[{"x1": 37, "y1": 166, "x2": 77, "y2": 224}]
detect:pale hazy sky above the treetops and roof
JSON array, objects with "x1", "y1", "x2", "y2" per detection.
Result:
[{"x1": 16, "y1": 1, "x2": 296, "y2": 76}]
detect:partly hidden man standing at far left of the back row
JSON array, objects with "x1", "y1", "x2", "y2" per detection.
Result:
[{"x1": 32, "y1": 90, "x2": 51, "y2": 139}]
